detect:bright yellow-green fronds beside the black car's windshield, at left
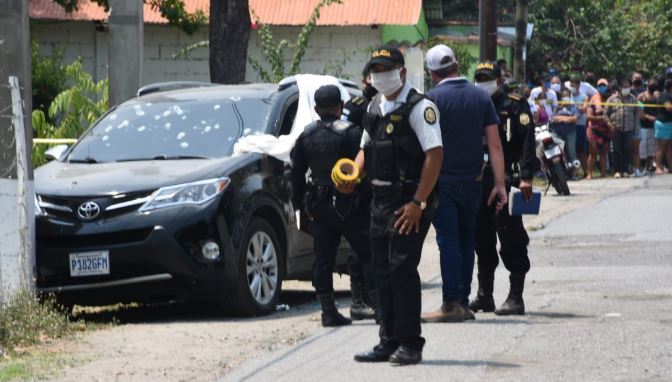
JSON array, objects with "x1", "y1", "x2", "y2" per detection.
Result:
[{"x1": 32, "y1": 61, "x2": 109, "y2": 167}]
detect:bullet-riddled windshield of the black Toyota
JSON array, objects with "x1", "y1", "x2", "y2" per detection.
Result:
[{"x1": 68, "y1": 97, "x2": 271, "y2": 163}]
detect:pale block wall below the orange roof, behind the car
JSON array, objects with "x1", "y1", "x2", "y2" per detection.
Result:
[{"x1": 31, "y1": 20, "x2": 380, "y2": 83}]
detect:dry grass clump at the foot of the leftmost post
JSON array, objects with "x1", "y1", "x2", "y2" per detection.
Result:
[{"x1": 0, "y1": 289, "x2": 71, "y2": 353}]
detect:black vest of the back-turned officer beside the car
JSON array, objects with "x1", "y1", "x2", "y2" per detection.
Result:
[{"x1": 303, "y1": 120, "x2": 361, "y2": 186}]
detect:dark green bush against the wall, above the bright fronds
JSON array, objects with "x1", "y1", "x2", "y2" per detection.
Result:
[{"x1": 30, "y1": 39, "x2": 67, "y2": 118}]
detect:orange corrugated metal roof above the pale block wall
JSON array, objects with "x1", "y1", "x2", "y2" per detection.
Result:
[{"x1": 29, "y1": 0, "x2": 422, "y2": 26}]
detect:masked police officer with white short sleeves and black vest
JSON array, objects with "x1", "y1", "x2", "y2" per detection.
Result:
[{"x1": 341, "y1": 46, "x2": 443, "y2": 365}]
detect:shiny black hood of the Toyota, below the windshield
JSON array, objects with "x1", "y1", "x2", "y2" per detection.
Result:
[{"x1": 35, "y1": 154, "x2": 253, "y2": 196}]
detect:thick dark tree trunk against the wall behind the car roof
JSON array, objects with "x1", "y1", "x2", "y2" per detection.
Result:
[{"x1": 209, "y1": 0, "x2": 251, "y2": 84}]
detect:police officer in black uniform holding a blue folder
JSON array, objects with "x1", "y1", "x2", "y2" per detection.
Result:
[{"x1": 469, "y1": 62, "x2": 536, "y2": 315}]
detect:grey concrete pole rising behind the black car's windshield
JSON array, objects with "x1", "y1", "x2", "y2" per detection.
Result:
[{"x1": 108, "y1": 0, "x2": 144, "y2": 106}]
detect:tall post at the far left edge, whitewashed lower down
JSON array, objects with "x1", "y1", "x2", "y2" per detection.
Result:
[{"x1": 0, "y1": 0, "x2": 35, "y2": 303}]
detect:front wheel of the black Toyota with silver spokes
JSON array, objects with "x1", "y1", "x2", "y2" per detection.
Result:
[{"x1": 223, "y1": 217, "x2": 284, "y2": 316}]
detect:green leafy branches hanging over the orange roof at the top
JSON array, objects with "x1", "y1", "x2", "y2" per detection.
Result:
[{"x1": 53, "y1": 0, "x2": 208, "y2": 35}]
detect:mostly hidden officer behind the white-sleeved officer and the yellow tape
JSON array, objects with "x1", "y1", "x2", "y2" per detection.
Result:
[{"x1": 341, "y1": 65, "x2": 380, "y2": 321}]
